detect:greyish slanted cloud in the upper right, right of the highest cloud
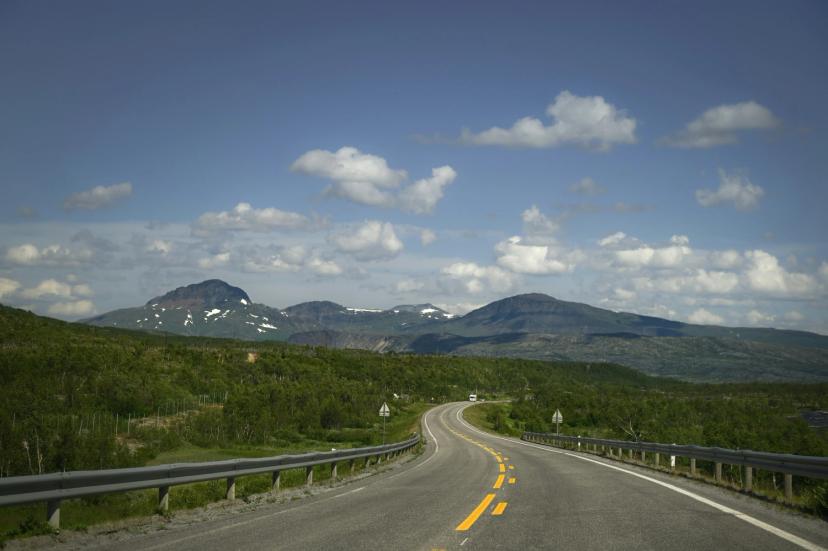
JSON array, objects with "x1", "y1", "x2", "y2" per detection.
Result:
[{"x1": 661, "y1": 101, "x2": 780, "y2": 148}]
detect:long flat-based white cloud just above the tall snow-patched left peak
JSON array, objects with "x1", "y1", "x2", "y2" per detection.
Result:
[{"x1": 194, "y1": 203, "x2": 312, "y2": 234}]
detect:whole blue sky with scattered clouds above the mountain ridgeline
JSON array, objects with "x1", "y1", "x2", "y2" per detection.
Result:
[{"x1": 0, "y1": 1, "x2": 828, "y2": 333}]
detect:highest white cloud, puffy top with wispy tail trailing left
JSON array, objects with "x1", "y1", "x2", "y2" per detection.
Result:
[{"x1": 460, "y1": 90, "x2": 636, "y2": 151}]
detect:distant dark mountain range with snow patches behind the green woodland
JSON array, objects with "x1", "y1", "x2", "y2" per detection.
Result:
[{"x1": 83, "y1": 279, "x2": 828, "y2": 382}]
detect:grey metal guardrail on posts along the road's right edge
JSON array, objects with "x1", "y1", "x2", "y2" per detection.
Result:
[{"x1": 521, "y1": 432, "x2": 828, "y2": 502}]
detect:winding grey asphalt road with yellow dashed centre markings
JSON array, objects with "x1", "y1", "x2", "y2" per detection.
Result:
[{"x1": 64, "y1": 403, "x2": 828, "y2": 551}]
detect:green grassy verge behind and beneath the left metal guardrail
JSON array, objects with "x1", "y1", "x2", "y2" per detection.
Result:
[{"x1": 0, "y1": 403, "x2": 433, "y2": 545}]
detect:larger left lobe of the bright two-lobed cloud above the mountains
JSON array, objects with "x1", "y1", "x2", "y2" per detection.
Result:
[{"x1": 290, "y1": 147, "x2": 406, "y2": 206}]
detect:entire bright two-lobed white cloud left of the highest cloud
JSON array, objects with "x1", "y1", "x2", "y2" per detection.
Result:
[{"x1": 290, "y1": 147, "x2": 457, "y2": 214}]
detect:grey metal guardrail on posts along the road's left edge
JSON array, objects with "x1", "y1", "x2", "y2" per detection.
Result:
[{"x1": 0, "y1": 434, "x2": 420, "y2": 528}]
